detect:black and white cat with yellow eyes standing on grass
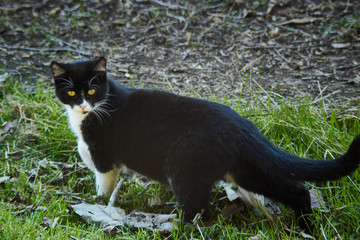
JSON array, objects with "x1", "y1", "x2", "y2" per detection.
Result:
[{"x1": 50, "y1": 57, "x2": 360, "y2": 231}]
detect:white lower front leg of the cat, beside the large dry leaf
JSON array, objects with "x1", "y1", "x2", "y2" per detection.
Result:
[{"x1": 95, "y1": 167, "x2": 120, "y2": 196}]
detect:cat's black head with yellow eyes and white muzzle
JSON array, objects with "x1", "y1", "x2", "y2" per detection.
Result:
[{"x1": 50, "y1": 57, "x2": 107, "y2": 114}]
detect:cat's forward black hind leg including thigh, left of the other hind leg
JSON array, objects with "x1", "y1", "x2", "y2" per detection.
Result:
[{"x1": 163, "y1": 137, "x2": 228, "y2": 222}]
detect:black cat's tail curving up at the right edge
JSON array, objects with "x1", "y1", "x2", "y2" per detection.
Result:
[{"x1": 278, "y1": 135, "x2": 360, "y2": 181}]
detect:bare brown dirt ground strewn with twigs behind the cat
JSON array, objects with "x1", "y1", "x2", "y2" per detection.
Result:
[{"x1": 0, "y1": 0, "x2": 360, "y2": 113}]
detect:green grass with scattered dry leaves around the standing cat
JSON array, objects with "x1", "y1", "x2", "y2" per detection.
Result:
[{"x1": 0, "y1": 74, "x2": 360, "y2": 239}]
